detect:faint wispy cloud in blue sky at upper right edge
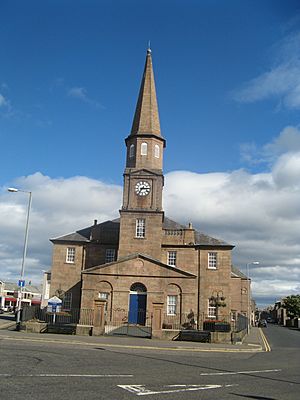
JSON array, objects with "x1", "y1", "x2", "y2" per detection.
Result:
[{"x1": 233, "y1": 32, "x2": 300, "y2": 109}]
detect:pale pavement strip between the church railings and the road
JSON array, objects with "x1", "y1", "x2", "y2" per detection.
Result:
[{"x1": 0, "y1": 324, "x2": 271, "y2": 353}]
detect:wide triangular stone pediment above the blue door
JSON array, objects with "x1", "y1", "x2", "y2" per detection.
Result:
[{"x1": 82, "y1": 254, "x2": 196, "y2": 279}]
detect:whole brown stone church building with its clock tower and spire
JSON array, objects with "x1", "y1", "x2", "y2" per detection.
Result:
[{"x1": 50, "y1": 49, "x2": 249, "y2": 329}]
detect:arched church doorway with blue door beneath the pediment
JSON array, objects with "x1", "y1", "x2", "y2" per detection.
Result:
[{"x1": 128, "y1": 282, "x2": 147, "y2": 325}]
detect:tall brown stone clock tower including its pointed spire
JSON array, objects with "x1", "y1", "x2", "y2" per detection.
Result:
[{"x1": 118, "y1": 49, "x2": 166, "y2": 259}]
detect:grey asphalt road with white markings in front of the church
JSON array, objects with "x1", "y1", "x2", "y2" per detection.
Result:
[{"x1": 0, "y1": 325, "x2": 300, "y2": 400}]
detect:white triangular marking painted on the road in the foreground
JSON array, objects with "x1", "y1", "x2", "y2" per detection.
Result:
[{"x1": 118, "y1": 385, "x2": 238, "y2": 396}]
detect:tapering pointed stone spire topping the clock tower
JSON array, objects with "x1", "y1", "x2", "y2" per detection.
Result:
[{"x1": 130, "y1": 47, "x2": 161, "y2": 136}]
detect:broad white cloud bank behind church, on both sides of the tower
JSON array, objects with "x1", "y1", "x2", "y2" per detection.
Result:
[{"x1": 0, "y1": 127, "x2": 300, "y2": 304}]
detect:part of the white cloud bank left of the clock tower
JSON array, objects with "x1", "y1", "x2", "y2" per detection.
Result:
[{"x1": 0, "y1": 172, "x2": 122, "y2": 283}]
